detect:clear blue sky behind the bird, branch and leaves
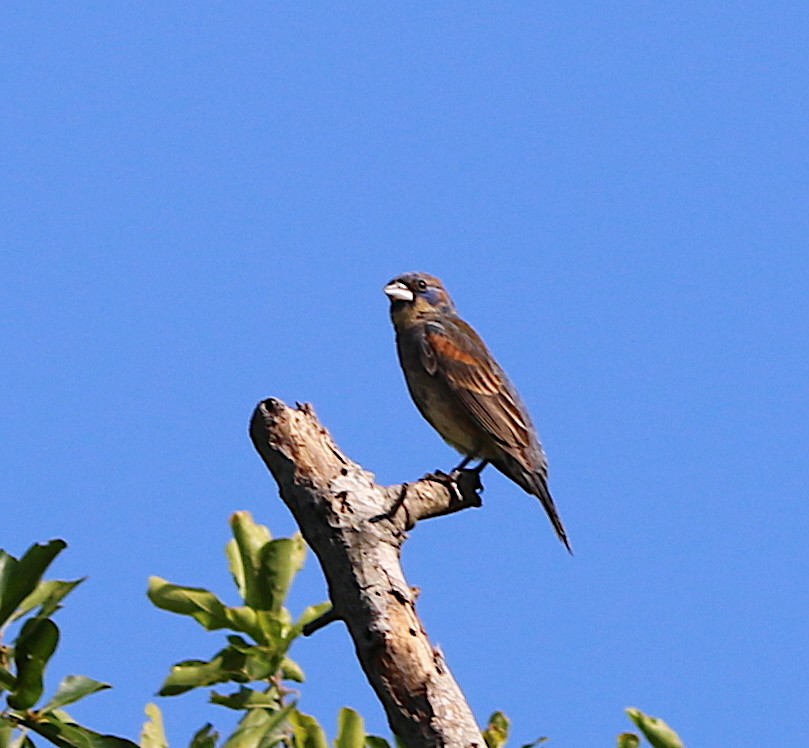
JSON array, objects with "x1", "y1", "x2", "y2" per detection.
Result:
[{"x1": 0, "y1": 2, "x2": 809, "y2": 748}]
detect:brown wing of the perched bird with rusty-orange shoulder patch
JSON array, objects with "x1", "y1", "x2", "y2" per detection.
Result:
[{"x1": 422, "y1": 319, "x2": 533, "y2": 449}]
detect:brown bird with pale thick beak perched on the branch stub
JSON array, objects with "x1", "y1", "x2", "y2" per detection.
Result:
[{"x1": 384, "y1": 273, "x2": 573, "y2": 554}]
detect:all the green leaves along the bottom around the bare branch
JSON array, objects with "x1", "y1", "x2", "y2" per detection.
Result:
[{"x1": 0, "y1": 512, "x2": 683, "y2": 748}]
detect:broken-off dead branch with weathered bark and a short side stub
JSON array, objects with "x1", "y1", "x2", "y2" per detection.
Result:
[{"x1": 250, "y1": 399, "x2": 484, "y2": 748}]
